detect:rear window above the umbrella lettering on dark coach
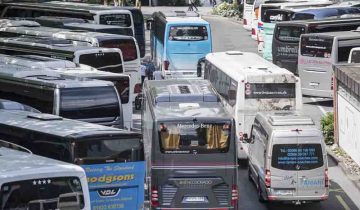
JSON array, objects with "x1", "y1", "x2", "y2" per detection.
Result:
[{"x1": 276, "y1": 26, "x2": 305, "y2": 42}]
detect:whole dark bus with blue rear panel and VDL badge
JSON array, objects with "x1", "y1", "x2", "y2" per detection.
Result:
[{"x1": 0, "y1": 110, "x2": 145, "y2": 210}]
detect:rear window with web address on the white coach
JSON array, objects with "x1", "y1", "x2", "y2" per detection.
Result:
[{"x1": 244, "y1": 83, "x2": 296, "y2": 111}]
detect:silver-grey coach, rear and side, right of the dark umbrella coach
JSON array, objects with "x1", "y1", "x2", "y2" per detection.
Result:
[{"x1": 298, "y1": 31, "x2": 360, "y2": 98}]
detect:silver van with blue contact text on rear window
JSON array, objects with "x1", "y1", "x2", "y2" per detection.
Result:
[{"x1": 247, "y1": 112, "x2": 329, "y2": 204}]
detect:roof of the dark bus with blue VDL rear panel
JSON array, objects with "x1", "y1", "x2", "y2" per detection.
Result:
[{"x1": 0, "y1": 110, "x2": 141, "y2": 141}]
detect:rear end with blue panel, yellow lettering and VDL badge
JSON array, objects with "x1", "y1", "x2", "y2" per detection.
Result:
[{"x1": 75, "y1": 138, "x2": 145, "y2": 210}]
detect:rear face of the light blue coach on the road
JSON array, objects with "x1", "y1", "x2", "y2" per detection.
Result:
[{"x1": 165, "y1": 24, "x2": 212, "y2": 76}]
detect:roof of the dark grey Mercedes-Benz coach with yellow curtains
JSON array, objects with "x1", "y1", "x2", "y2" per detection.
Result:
[{"x1": 145, "y1": 80, "x2": 231, "y2": 120}]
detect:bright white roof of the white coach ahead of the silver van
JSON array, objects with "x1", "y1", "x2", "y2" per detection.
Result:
[{"x1": 206, "y1": 51, "x2": 295, "y2": 82}]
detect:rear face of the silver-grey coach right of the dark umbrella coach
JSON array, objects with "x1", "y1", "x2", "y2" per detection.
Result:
[{"x1": 298, "y1": 36, "x2": 335, "y2": 97}]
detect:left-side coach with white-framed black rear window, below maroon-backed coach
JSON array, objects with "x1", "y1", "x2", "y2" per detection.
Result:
[{"x1": 0, "y1": 36, "x2": 124, "y2": 73}]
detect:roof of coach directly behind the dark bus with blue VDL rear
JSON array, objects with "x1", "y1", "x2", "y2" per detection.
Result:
[{"x1": 0, "y1": 65, "x2": 113, "y2": 88}]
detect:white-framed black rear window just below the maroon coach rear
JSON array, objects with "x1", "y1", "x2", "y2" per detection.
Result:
[{"x1": 79, "y1": 52, "x2": 123, "y2": 73}]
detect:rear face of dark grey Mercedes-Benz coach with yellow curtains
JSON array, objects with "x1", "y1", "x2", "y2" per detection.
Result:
[{"x1": 150, "y1": 120, "x2": 238, "y2": 209}]
